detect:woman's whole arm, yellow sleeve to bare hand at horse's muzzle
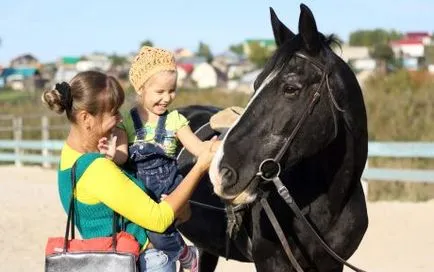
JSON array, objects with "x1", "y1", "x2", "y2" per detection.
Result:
[{"x1": 77, "y1": 141, "x2": 216, "y2": 232}]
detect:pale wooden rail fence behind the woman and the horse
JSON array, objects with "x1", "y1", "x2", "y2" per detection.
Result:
[{"x1": 0, "y1": 115, "x2": 434, "y2": 186}]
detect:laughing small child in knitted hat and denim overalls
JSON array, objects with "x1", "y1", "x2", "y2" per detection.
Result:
[{"x1": 99, "y1": 46, "x2": 214, "y2": 271}]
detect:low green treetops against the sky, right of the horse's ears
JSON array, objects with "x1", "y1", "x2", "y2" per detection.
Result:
[{"x1": 349, "y1": 28, "x2": 403, "y2": 47}]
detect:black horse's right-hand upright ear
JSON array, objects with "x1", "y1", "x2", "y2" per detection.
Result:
[{"x1": 298, "y1": 4, "x2": 321, "y2": 54}]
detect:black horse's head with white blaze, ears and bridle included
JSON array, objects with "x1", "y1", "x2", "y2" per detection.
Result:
[{"x1": 210, "y1": 4, "x2": 366, "y2": 204}]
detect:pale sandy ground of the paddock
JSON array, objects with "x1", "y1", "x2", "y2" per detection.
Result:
[{"x1": 0, "y1": 166, "x2": 434, "y2": 272}]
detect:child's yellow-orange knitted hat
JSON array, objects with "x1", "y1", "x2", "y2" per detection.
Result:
[{"x1": 129, "y1": 46, "x2": 176, "y2": 92}]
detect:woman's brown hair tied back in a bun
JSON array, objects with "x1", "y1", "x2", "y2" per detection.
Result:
[{"x1": 41, "y1": 71, "x2": 125, "y2": 123}]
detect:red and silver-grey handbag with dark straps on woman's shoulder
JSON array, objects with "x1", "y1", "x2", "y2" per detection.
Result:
[{"x1": 45, "y1": 160, "x2": 140, "y2": 272}]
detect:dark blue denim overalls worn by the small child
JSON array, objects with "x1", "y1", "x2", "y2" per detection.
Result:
[{"x1": 128, "y1": 108, "x2": 184, "y2": 258}]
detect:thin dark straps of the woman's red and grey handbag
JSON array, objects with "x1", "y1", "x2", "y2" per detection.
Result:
[{"x1": 63, "y1": 157, "x2": 125, "y2": 253}]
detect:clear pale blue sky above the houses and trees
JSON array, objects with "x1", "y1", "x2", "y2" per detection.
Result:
[{"x1": 0, "y1": 0, "x2": 434, "y2": 65}]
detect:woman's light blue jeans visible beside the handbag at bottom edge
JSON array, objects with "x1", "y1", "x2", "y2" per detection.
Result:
[{"x1": 139, "y1": 248, "x2": 176, "y2": 272}]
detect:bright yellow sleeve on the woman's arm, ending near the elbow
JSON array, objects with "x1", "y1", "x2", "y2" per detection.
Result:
[{"x1": 77, "y1": 158, "x2": 175, "y2": 232}]
